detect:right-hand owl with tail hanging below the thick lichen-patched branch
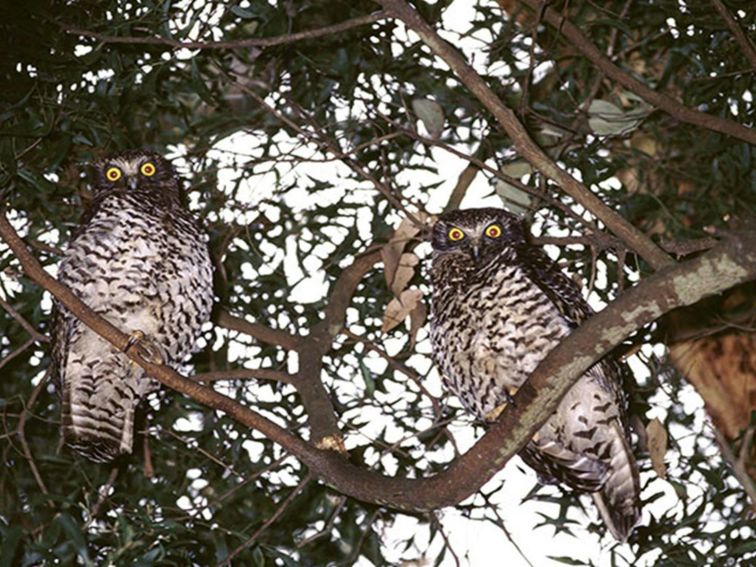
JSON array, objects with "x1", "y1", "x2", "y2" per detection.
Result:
[{"x1": 431, "y1": 208, "x2": 640, "y2": 541}]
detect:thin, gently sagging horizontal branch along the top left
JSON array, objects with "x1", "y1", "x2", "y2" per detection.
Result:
[{"x1": 64, "y1": 12, "x2": 386, "y2": 49}]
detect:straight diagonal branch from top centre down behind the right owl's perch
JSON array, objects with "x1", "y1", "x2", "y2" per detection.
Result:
[{"x1": 375, "y1": 0, "x2": 674, "y2": 270}]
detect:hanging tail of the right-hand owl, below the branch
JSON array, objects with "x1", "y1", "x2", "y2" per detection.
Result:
[{"x1": 592, "y1": 422, "x2": 640, "y2": 542}]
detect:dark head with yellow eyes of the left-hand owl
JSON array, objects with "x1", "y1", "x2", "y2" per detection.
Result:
[{"x1": 90, "y1": 150, "x2": 179, "y2": 198}]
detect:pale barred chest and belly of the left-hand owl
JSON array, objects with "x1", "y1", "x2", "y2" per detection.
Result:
[{"x1": 60, "y1": 194, "x2": 212, "y2": 363}]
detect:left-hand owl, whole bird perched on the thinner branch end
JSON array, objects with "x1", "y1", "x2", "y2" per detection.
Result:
[{"x1": 52, "y1": 150, "x2": 213, "y2": 462}]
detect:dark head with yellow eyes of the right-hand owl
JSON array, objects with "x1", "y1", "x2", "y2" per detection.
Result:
[{"x1": 432, "y1": 208, "x2": 526, "y2": 264}]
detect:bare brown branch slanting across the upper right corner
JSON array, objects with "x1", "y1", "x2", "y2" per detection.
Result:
[{"x1": 516, "y1": 0, "x2": 756, "y2": 144}]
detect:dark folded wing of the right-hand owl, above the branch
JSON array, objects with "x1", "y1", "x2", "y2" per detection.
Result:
[{"x1": 517, "y1": 244, "x2": 593, "y2": 327}]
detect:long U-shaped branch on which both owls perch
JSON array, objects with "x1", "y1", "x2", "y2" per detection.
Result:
[{"x1": 0, "y1": 211, "x2": 756, "y2": 511}]
